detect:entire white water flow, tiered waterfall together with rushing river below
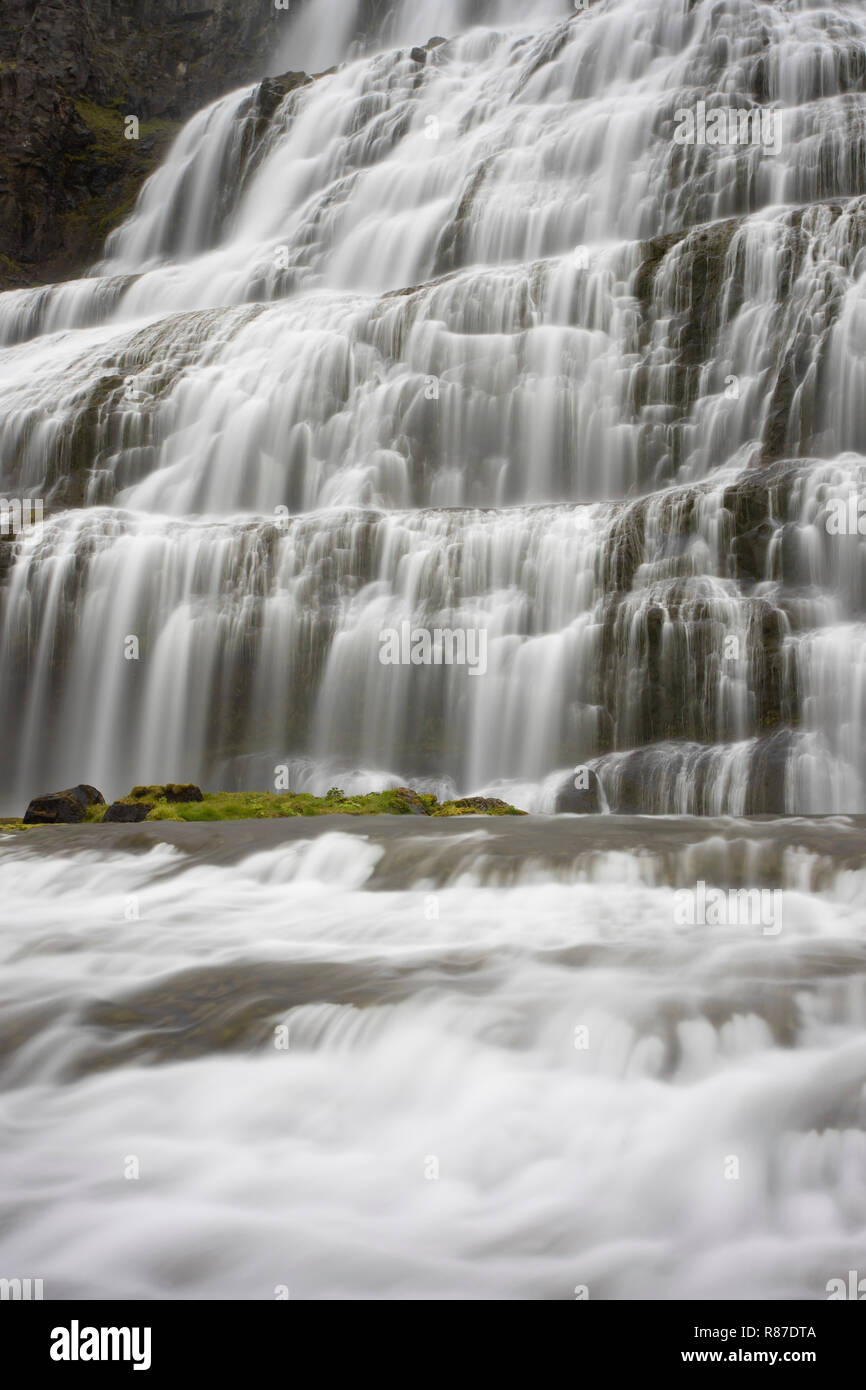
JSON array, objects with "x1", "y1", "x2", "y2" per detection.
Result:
[{"x1": 0, "y1": 0, "x2": 866, "y2": 1298}]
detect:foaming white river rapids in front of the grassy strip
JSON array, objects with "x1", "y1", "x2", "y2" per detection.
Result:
[{"x1": 0, "y1": 821, "x2": 866, "y2": 1300}]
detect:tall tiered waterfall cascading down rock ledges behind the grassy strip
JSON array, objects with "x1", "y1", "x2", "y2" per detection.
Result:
[{"x1": 0, "y1": 0, "x2": 866, "y2": 815}]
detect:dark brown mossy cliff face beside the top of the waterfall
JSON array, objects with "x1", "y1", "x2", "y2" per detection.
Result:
[{"x1": 0, "y1": 0, "x2": 280, "y2": 289}]
